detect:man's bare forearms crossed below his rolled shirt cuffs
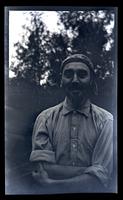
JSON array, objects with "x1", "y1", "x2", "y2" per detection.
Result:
[{"x1": 33, "y1": 162, "x2": 102, "y2": 192}]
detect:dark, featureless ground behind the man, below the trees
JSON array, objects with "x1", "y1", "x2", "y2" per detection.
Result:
[{"x1": 5, "y1": 79, "x2": 116, "y2": 194}]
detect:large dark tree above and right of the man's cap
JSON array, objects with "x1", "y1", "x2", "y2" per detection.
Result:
[{"x1": 59, "y1": 10, "x2": 115, "y2": 79}]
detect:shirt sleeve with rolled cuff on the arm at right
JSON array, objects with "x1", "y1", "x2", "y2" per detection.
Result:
[{"x1": 84, "y1": 118, "x2": 113, "y2": 187}]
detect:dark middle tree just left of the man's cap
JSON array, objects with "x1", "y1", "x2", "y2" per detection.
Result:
[{"x1": 47, "y1": 33, "x2": 69, "y2": 86}]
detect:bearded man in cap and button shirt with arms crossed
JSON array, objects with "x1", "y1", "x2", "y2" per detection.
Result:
[{"x1": 30, "y1": 54, "x2": 113, "y2": 192}]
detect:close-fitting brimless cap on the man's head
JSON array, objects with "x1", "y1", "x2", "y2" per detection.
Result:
[{"x1": 61, "y1": 54, "x2": 94, "y2": 72}]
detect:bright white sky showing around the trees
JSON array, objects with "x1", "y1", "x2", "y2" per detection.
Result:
[{"x1": 9, "y1": 11, "x2": 114, "y2": 78}]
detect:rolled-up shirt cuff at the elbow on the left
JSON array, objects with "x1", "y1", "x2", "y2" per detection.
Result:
[{"x1": 30, "y1": 150, "x2": 56, "y2": 163}]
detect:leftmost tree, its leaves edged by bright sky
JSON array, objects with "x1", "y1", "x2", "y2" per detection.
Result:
[{"x1": 10, "y1": 12, "x2": 50, "y2": 85}]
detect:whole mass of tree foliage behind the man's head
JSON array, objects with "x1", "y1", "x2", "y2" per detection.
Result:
[{"x1": 11, "y1": 9, "x2": 115, "y2": 86}]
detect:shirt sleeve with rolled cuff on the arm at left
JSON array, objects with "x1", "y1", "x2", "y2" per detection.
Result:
[{"x1": 30, "y1": 114, "x2": 55, "y2": 163}]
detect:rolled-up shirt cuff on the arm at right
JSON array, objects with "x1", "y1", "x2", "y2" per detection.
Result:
[{"x1": 84, "y1": 165, "x2": 109, "y2": 187}]
